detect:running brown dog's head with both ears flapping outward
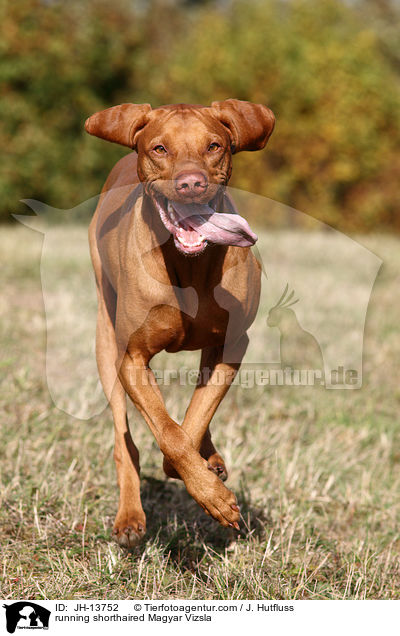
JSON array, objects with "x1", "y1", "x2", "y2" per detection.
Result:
[{"x1": 85, "y1": 99, "x2": 275, "y2": 254}]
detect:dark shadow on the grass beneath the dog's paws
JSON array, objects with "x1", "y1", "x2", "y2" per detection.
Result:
[{"x1": 131, "y1": 476, "x2": 270, "y2": 570}]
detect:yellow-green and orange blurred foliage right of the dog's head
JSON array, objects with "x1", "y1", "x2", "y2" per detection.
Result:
[{"x1": 146, "y1": 0, "x2": 400, "y2": 230}]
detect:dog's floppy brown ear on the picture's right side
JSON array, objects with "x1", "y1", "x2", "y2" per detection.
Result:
[{"x1": 211, "y1": 99, "x2": 275, "y2": 153}]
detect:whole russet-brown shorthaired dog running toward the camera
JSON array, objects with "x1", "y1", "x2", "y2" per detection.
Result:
[{"x1": 86, "y1": 99, "x2": 274, "y2": 548}]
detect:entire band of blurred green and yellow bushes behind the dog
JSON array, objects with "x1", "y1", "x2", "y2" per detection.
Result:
[{"x1": 0, "y1": 0, "x2": 400, "y2": 231}]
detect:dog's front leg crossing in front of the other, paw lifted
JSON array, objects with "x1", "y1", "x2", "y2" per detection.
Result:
[{"x1": 118, "y1": 349, "x2": 239, "y2": 527}]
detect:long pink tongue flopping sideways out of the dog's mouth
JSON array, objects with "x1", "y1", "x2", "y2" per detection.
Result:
[{"x1": 172, "y1": 201, "x2": 258, "y2": 247}]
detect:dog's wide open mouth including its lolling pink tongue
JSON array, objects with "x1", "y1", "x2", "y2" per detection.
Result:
[{"x1": 154, "y1": 195, "x2": 257, "y2": 255}]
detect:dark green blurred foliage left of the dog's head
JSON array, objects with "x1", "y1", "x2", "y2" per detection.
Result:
[{"x1": 0, "y1": 0, "x2": 147, "y2": 218}]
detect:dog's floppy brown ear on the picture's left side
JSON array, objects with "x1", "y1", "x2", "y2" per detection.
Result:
[{"x1": 85, "y1": 104, "x2": 151, "y2": 148}]
